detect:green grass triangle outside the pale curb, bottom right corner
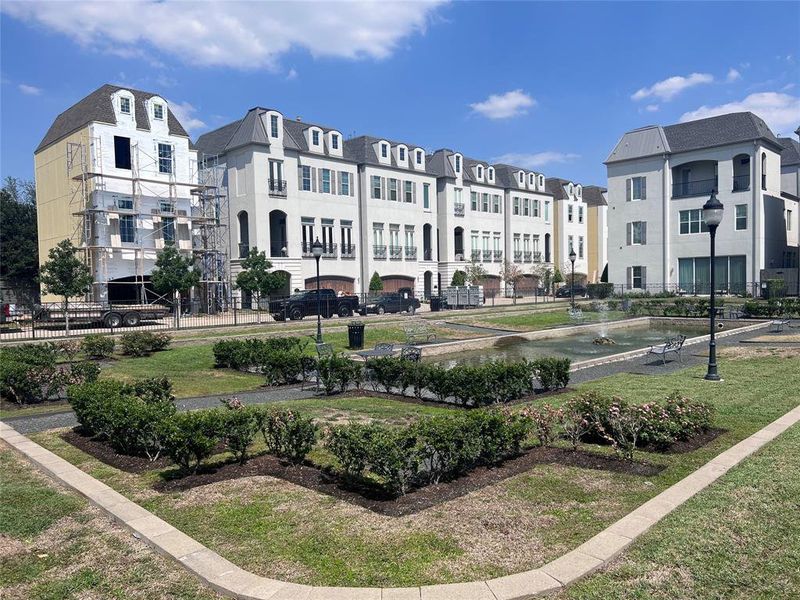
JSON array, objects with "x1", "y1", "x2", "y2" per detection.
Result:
[{"x1": 562, "y1": 425, "x2": 800, "y2": 600}]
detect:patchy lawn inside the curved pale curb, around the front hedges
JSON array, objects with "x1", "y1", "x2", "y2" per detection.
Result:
[{"x1": 33, "y1": 352, "x2": 800, "y2": 597}]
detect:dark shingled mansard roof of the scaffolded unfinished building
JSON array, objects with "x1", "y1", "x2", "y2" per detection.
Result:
[{"x1": 34, "y1": 84, "x2": 193, "y2": 154}]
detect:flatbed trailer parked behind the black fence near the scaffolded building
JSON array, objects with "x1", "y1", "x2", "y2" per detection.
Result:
[{"x1": 33, "y1": 302, "x2": 169, "y2": 327}]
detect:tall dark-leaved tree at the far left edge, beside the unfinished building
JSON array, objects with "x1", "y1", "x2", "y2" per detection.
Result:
[{"x1": 0, "y1": 177, "x2": 39, "y2": 301}]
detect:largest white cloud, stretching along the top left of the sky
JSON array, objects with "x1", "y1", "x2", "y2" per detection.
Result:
[{"x1": 2, "y1": 0, "x2": 442, "y2": 70}]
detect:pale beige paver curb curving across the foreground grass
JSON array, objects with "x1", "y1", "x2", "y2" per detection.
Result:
[{"x1": 0, "y1": 400, "x2": 800, "y2": 600}]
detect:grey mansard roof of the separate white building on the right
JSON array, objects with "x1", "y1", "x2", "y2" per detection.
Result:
[{"x1": 606, "y1": 112, "x2": 781, "y2": 164}]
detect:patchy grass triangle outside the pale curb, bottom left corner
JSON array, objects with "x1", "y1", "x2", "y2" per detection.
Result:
[{"x1": 0, "y1": 445, "x2": 218, "y2": 600}]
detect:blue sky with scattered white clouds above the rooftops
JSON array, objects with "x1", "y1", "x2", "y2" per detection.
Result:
[{"x1": 0, "y1": 1, "x2": 800, "y2": 185}]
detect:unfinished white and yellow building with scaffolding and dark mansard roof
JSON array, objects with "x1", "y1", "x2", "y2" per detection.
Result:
[{"x1": 34, "y1": 85, "x2": 230, "y2": 312}]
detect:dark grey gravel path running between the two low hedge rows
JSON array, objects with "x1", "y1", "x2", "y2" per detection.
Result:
[{"x1": 4, "y1": 321, "x2": 784, "y2": 434}]
